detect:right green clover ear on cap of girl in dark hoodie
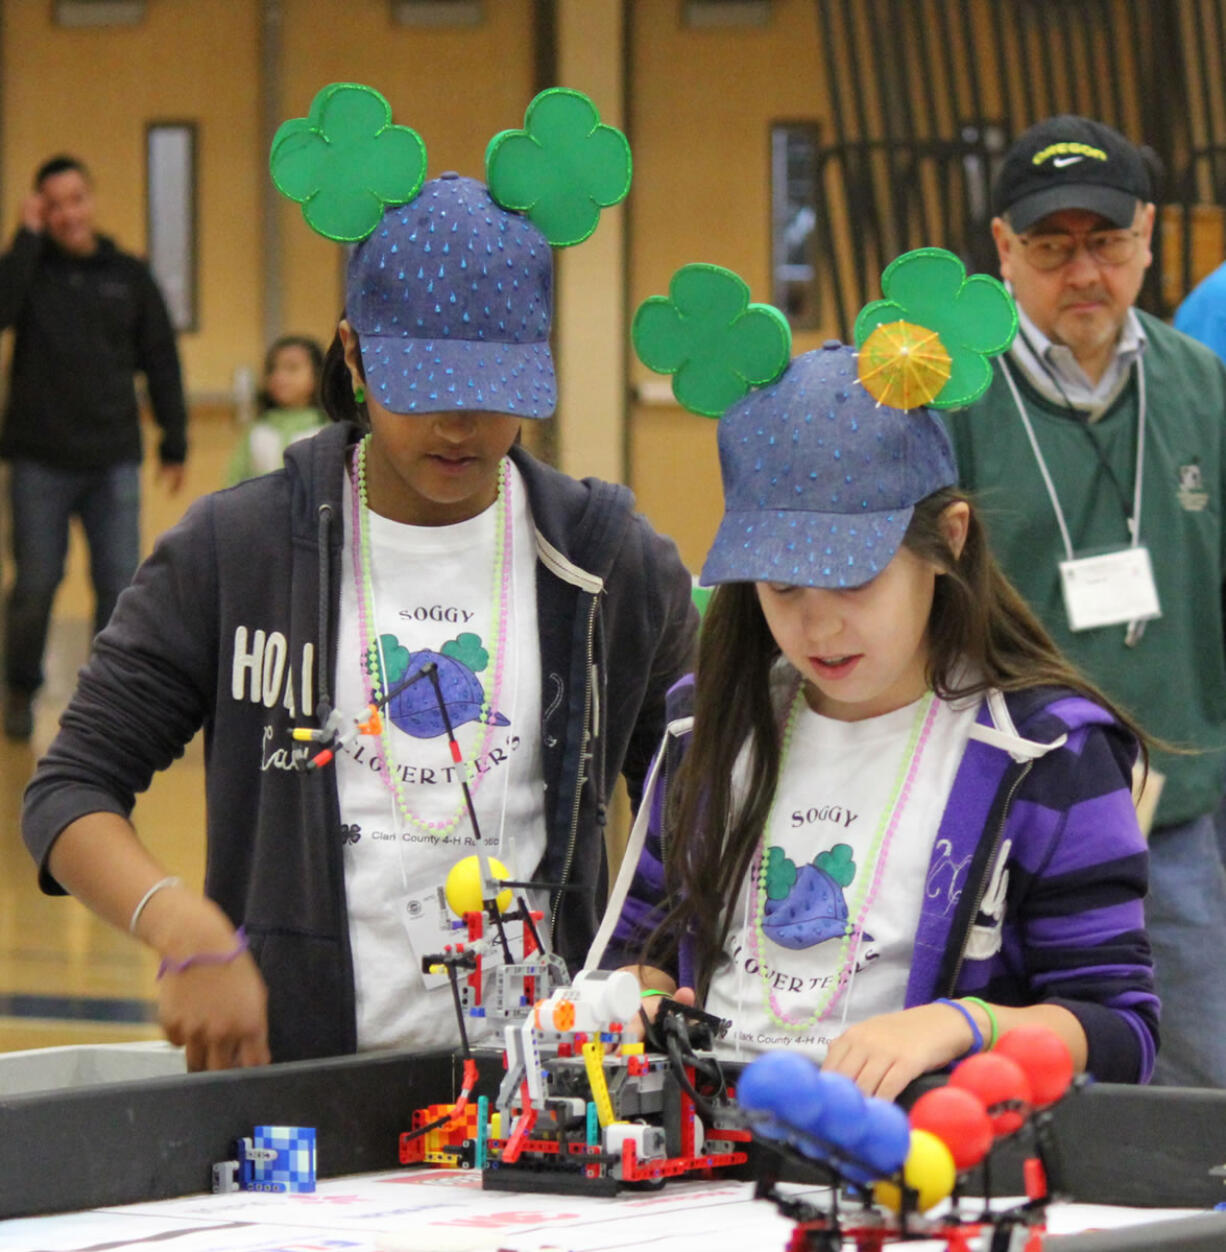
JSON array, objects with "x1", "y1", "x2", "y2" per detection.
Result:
[{"x1": 486, "y1": 86, "x2": 631, "y2": 248}]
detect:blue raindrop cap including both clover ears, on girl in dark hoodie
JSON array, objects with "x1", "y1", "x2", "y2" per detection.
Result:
[{"x1": 268, "y1": 83, "x2": 632, "y2": 417}]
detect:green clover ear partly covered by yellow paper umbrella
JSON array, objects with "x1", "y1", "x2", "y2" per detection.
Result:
[{"x1": 854, "y1": 248, "x2": 1017, "y2": 408}]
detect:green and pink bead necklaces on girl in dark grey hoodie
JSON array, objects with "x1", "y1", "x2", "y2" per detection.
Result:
[{"x1": 352, "y1": 434, "x2": 515, "y2": 835}]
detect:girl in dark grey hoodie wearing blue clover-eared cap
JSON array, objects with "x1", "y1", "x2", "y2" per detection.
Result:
[{"x1": 23, "y1": 84, "x2": 698, "y2": 1069}]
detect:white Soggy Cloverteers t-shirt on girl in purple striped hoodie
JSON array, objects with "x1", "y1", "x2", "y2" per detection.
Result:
[{"x1": 706, "y1": 696, "x2": 979, "y2": 1059}]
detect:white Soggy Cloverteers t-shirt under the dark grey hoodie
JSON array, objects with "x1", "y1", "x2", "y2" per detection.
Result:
[{"x1": 336, "y1": 464, "x2": 545, "y2": 1049}]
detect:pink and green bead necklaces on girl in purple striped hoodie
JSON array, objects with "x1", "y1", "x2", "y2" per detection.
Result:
[{"x1": 749, "y1": 686, "x2": 939, "y2": 1030}]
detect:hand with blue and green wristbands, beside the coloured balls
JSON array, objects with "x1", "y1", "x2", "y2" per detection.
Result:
[{"x1": 822, "y1": 1004, "x2": 974, "y2": 1099}]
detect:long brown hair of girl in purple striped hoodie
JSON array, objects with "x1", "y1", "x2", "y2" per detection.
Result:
[{"x1": 642, "y1": 487, "x2": 1146, "y2": 999}]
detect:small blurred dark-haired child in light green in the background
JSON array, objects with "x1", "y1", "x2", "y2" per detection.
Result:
[{"x1": 225, "y1": 334, "x2": 328, "y2": 487}]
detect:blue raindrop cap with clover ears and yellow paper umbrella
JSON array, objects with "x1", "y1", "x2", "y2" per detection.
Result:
[{"x1": 631, "y1": 248, "x2": 1017, "y2": 588}]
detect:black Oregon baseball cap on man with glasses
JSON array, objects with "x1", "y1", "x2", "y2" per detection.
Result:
[{"x1": 992, "y1": 114, "x2": 1153, "y2": 232}]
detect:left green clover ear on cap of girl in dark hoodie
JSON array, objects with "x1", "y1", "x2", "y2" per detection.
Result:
[{"x1": 268, "y1": 83, "x2": 426, "y2": 243}]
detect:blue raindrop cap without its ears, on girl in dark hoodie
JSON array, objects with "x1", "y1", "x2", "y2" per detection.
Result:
[{"x1": 346, "y1": 174, "x2": 557, "y2": 417}]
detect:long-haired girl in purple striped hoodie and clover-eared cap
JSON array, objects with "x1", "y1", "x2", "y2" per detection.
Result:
[{"x1": 589, "y1": 249, "x2": 1157, "y2": 1098}]
